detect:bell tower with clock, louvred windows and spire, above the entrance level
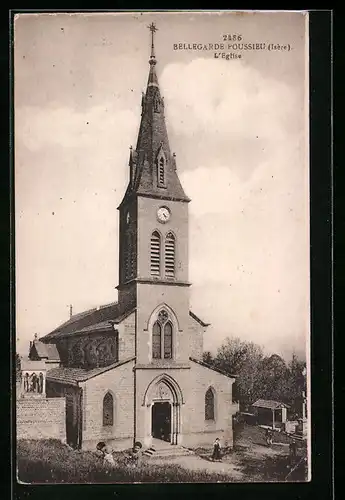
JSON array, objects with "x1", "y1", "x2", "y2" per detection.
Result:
[{"x1": 118, "y1": 23, "x2": 190, "y2": 363}]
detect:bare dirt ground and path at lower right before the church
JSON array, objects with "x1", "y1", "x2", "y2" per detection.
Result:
[{"x1": 146, "y1": 426, "x2": 305, "y2": 482}]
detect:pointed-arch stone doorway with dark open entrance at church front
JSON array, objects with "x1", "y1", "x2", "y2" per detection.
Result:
[{"x1": 143, "y1": 374, "x2": 183, "y2": 444}]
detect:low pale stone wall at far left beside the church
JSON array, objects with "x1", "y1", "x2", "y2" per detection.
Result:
[{"x1": 17, "y1": 398, "x2": 66, "y2": 442}]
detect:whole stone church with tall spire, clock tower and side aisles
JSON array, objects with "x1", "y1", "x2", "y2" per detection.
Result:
[{"x1": 30, "y1": 23, "x2": 238, "y2": 449}]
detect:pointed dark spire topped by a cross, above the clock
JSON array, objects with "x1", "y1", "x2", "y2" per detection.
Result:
[{"x1": 121, "y1": 23, "x2": 190, "y2": 205}]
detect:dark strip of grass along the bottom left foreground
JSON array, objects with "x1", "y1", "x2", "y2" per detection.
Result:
[{"x1": 17, "y1": 439, "x2": 229, "y2": 484}]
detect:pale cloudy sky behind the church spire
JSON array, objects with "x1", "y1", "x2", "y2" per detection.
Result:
[{"x1": 14, "y1": 12, "x2": 309, "y2": 357}]
